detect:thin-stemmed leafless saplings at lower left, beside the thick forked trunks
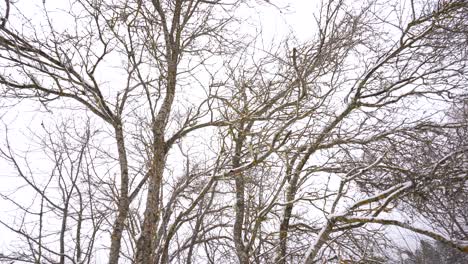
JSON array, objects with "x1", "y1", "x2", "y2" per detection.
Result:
[{"x1": 0, "y1": 119, "x2": 108, "y2": 263}]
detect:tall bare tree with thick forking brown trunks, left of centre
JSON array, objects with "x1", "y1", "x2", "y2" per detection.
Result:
[{"x1": 0, "y1": 1, "x2": 247, "y2": 263}]
